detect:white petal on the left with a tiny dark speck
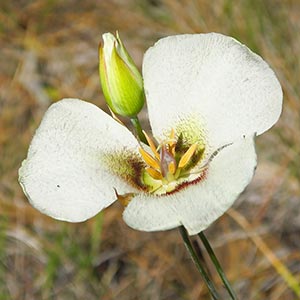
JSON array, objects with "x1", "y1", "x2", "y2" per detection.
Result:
[{"x1": 19, "y1": 99, "x2": 138, "y2": 222}]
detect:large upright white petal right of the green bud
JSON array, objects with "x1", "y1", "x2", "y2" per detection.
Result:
[{"x1": 143, "y1": 33, "x2": 282, "y2": 147}]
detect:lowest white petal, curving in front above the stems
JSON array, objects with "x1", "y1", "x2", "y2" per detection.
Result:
[{"x1": 123, "y1": 138, "x2": 256, "y2": 234}]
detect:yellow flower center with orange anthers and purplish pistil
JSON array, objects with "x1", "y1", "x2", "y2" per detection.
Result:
[{"x1": 139, "y1": 129, "x2": 204, "y2": 195}]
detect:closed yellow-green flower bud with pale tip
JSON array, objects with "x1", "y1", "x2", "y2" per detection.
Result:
[{"x1": 99, "y1": 33, "x2": 145, "y2": 117}]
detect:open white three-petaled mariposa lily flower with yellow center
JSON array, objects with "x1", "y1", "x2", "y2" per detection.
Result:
[{"x1": 19, "y1": 33, "x2": 282, "y2": 234}]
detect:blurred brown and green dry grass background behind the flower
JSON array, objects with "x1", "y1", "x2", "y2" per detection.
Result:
[{"x1": 0, "y1": 0, "x2": 300, "y2": 300}]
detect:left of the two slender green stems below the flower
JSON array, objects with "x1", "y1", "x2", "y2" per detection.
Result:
[{"x1": 179, "y1": 226, "x2": 220, "y2": 300}]
